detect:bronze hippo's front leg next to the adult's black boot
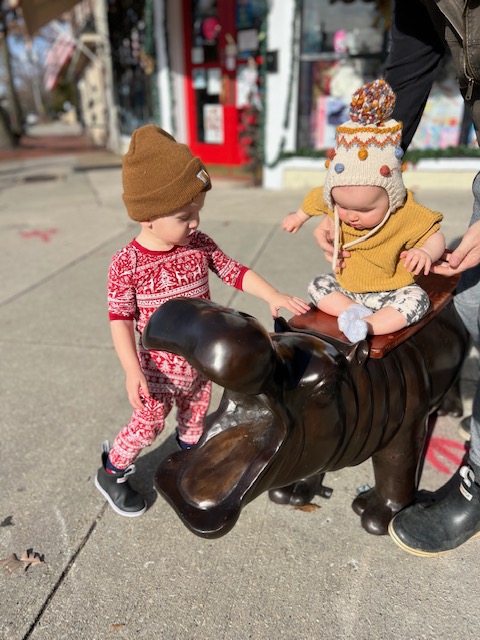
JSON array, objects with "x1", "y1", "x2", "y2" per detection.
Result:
[{"x1": 352, "y1": 417, "x2": 428, "y2": 535}]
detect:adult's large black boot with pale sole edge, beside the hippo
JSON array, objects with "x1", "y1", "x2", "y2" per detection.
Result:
[{"x1": 388, "y1": 466, "x2": 480, "y2": 556}]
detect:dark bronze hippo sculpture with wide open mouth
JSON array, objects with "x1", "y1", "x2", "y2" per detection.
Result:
[{"x1": 143, "y1": 282, "x2": 469, "y2": 538}]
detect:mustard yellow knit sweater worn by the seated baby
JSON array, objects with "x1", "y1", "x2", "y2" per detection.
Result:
[{"x1": 302, "y1": 187, "x2": 443, "y2": 293}]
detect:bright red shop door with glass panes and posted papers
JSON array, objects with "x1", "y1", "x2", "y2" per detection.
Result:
[{"x1": 183, "y1": 0, "x2": 268, "y2": 165}]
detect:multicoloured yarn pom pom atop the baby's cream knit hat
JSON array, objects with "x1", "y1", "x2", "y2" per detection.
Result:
[{"x1": 350, "y1": 80, "x2": 395, "y2": 125}]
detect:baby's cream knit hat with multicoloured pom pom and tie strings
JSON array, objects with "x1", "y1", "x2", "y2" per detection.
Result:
[{"x1": 323, "y1": 80, "x2": 407, "y2": 264}]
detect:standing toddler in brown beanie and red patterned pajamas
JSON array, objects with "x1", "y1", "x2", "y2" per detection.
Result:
[{"x1": 95, "y1": 125, "x2": 309, "y2": 516}]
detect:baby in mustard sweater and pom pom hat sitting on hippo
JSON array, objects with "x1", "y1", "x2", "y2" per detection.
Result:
[{"x1": 282, "y1": 80, "x2": 445, "y2": 342}]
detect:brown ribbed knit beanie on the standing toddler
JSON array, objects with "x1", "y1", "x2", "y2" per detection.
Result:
[{"x1": 122, "y1": 124, "x2": 212, "y2": 222}]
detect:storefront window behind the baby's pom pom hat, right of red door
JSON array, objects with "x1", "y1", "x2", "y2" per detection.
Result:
[{"x1": 297, "y1": 0, "x2": 386, "y2": 150}]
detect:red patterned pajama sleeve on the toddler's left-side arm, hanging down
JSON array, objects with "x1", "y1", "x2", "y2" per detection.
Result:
[{"x1": 108, "y1": 247, "x2": 137, "y2": 320}]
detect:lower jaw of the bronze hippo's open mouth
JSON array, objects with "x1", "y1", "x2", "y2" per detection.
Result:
[{"x1": 155, "y1": 423, "x2": 285, "y2": 538}]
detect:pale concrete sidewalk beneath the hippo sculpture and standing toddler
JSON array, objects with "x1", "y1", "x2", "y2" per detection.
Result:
[{"x1": 0, "y1": 142, "x2": 480, "y2": 640}]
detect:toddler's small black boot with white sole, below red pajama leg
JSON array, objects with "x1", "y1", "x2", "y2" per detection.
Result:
[{"x1": 95, "y1": 441, "x2": 147, "y2": 518}]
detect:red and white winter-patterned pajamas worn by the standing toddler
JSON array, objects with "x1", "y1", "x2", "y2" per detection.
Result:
[{"x1": 108, "y1": 231, "x2": 248, "y2": 469}]
